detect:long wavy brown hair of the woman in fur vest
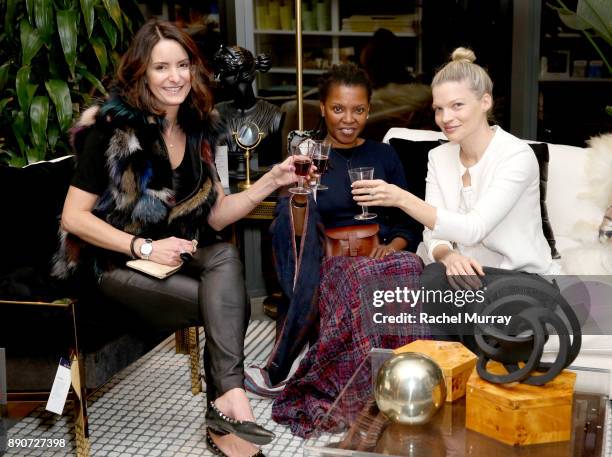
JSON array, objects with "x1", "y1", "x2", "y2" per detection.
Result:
[{"x1": 114, "y1": 19, "x2": 214, "y2": 120}]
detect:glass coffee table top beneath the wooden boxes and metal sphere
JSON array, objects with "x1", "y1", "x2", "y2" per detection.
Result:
[{"x1": 304, "y1": 349, "x2": 610, "y2": 457}]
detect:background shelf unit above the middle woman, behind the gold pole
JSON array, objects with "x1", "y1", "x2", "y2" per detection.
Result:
[{"x1": 236, "y1": 0, "x2": 422, "y2": 95}]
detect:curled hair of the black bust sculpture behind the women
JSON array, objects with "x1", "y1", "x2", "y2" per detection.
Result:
[{"x1": 213, "y1": 45, "x2": 272, "y2": 82}]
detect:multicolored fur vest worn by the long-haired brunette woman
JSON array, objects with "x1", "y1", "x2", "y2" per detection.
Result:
[{"x1": 52, "y1": 97, "x2": 222, "y2": 279}]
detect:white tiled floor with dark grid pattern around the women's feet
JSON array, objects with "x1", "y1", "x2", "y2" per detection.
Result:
[{"x1": 6, "y1": 321, "x2": 302, "y2": 457}]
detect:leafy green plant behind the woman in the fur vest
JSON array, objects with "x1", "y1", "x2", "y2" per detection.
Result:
[{"x1": 0, "y1": 0, "x2": 143, "y2": 166}]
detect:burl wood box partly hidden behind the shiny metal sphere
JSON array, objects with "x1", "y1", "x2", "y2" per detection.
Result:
[{"x1": 395, "y1": 340, "x2": 477, "y2": 401}]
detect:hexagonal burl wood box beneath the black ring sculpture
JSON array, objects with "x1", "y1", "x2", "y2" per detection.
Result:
[{"x1": 465, "y1": 362, "x2": 576, "y2": 446}]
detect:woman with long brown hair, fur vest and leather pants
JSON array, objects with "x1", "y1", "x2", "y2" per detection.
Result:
[{"x1": 54, "y1": 20, "x2": 296, "y2": 456}]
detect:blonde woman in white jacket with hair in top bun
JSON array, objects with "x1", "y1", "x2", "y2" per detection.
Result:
[{"x1": 353, "y1": 48, "x2": 558, "y2": 346}]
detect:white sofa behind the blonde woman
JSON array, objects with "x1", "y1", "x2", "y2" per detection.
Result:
[{"x1": 383, "y1": 128, "x2": 612, "y2": 395}]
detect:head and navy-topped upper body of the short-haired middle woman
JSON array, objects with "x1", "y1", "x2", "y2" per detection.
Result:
[{"x1": 310, "y1": 64, "x2": 418, "y2": 251}]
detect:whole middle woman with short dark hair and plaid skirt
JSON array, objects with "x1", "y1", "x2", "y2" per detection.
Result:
[{"x1": 247, "y1": 65, "x2": 424, "y2": 436}]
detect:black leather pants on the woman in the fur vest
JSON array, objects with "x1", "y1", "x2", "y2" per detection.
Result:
[{"x1": 100, "y1": 243, "x2": 250, "y2": 402}]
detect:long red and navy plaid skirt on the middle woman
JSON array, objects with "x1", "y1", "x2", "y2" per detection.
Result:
[{"x1": 272, "y1": 251, "x2": 429, "y2": 437}]
